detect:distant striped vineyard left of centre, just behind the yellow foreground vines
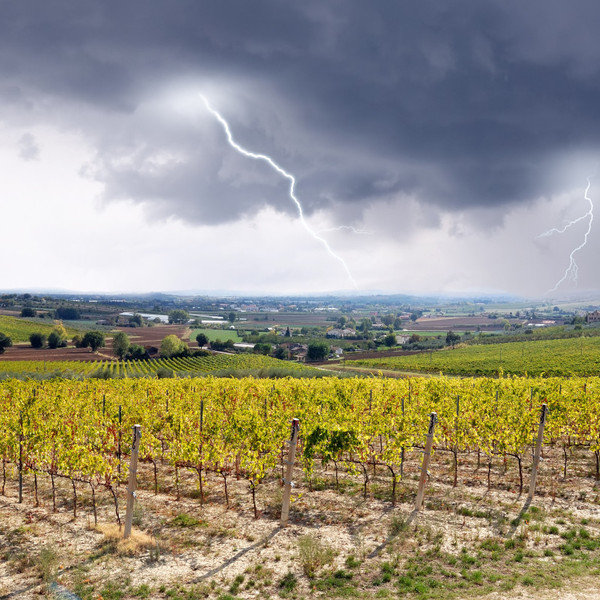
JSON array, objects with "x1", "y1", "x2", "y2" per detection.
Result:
[{"x1": 0, "y1": 354, "x2": 321, "y2": 378}]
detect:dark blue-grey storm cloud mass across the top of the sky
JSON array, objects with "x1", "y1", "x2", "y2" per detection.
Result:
[{"x1": 0, "y1": 0, "x2": 600, "y2": 222}]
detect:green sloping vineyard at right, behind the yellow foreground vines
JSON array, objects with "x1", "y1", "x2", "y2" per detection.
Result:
[{"x1": 346, "y1": 337, "x2": 600, "y2": 377}]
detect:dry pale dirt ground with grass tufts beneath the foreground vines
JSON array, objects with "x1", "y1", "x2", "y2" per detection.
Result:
[{"x1": 0, "y1": 448, "x2": 600, "y2": 600}]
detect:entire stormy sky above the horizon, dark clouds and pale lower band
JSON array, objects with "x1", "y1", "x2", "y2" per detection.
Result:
[{"x1": 0, "y1": 0, "x2": 600, "y2": 300}]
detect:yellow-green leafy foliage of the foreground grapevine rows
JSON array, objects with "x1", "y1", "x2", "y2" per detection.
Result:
[{"x1": 0, "y1": 378, "x2": 600, "y2": 511}]
